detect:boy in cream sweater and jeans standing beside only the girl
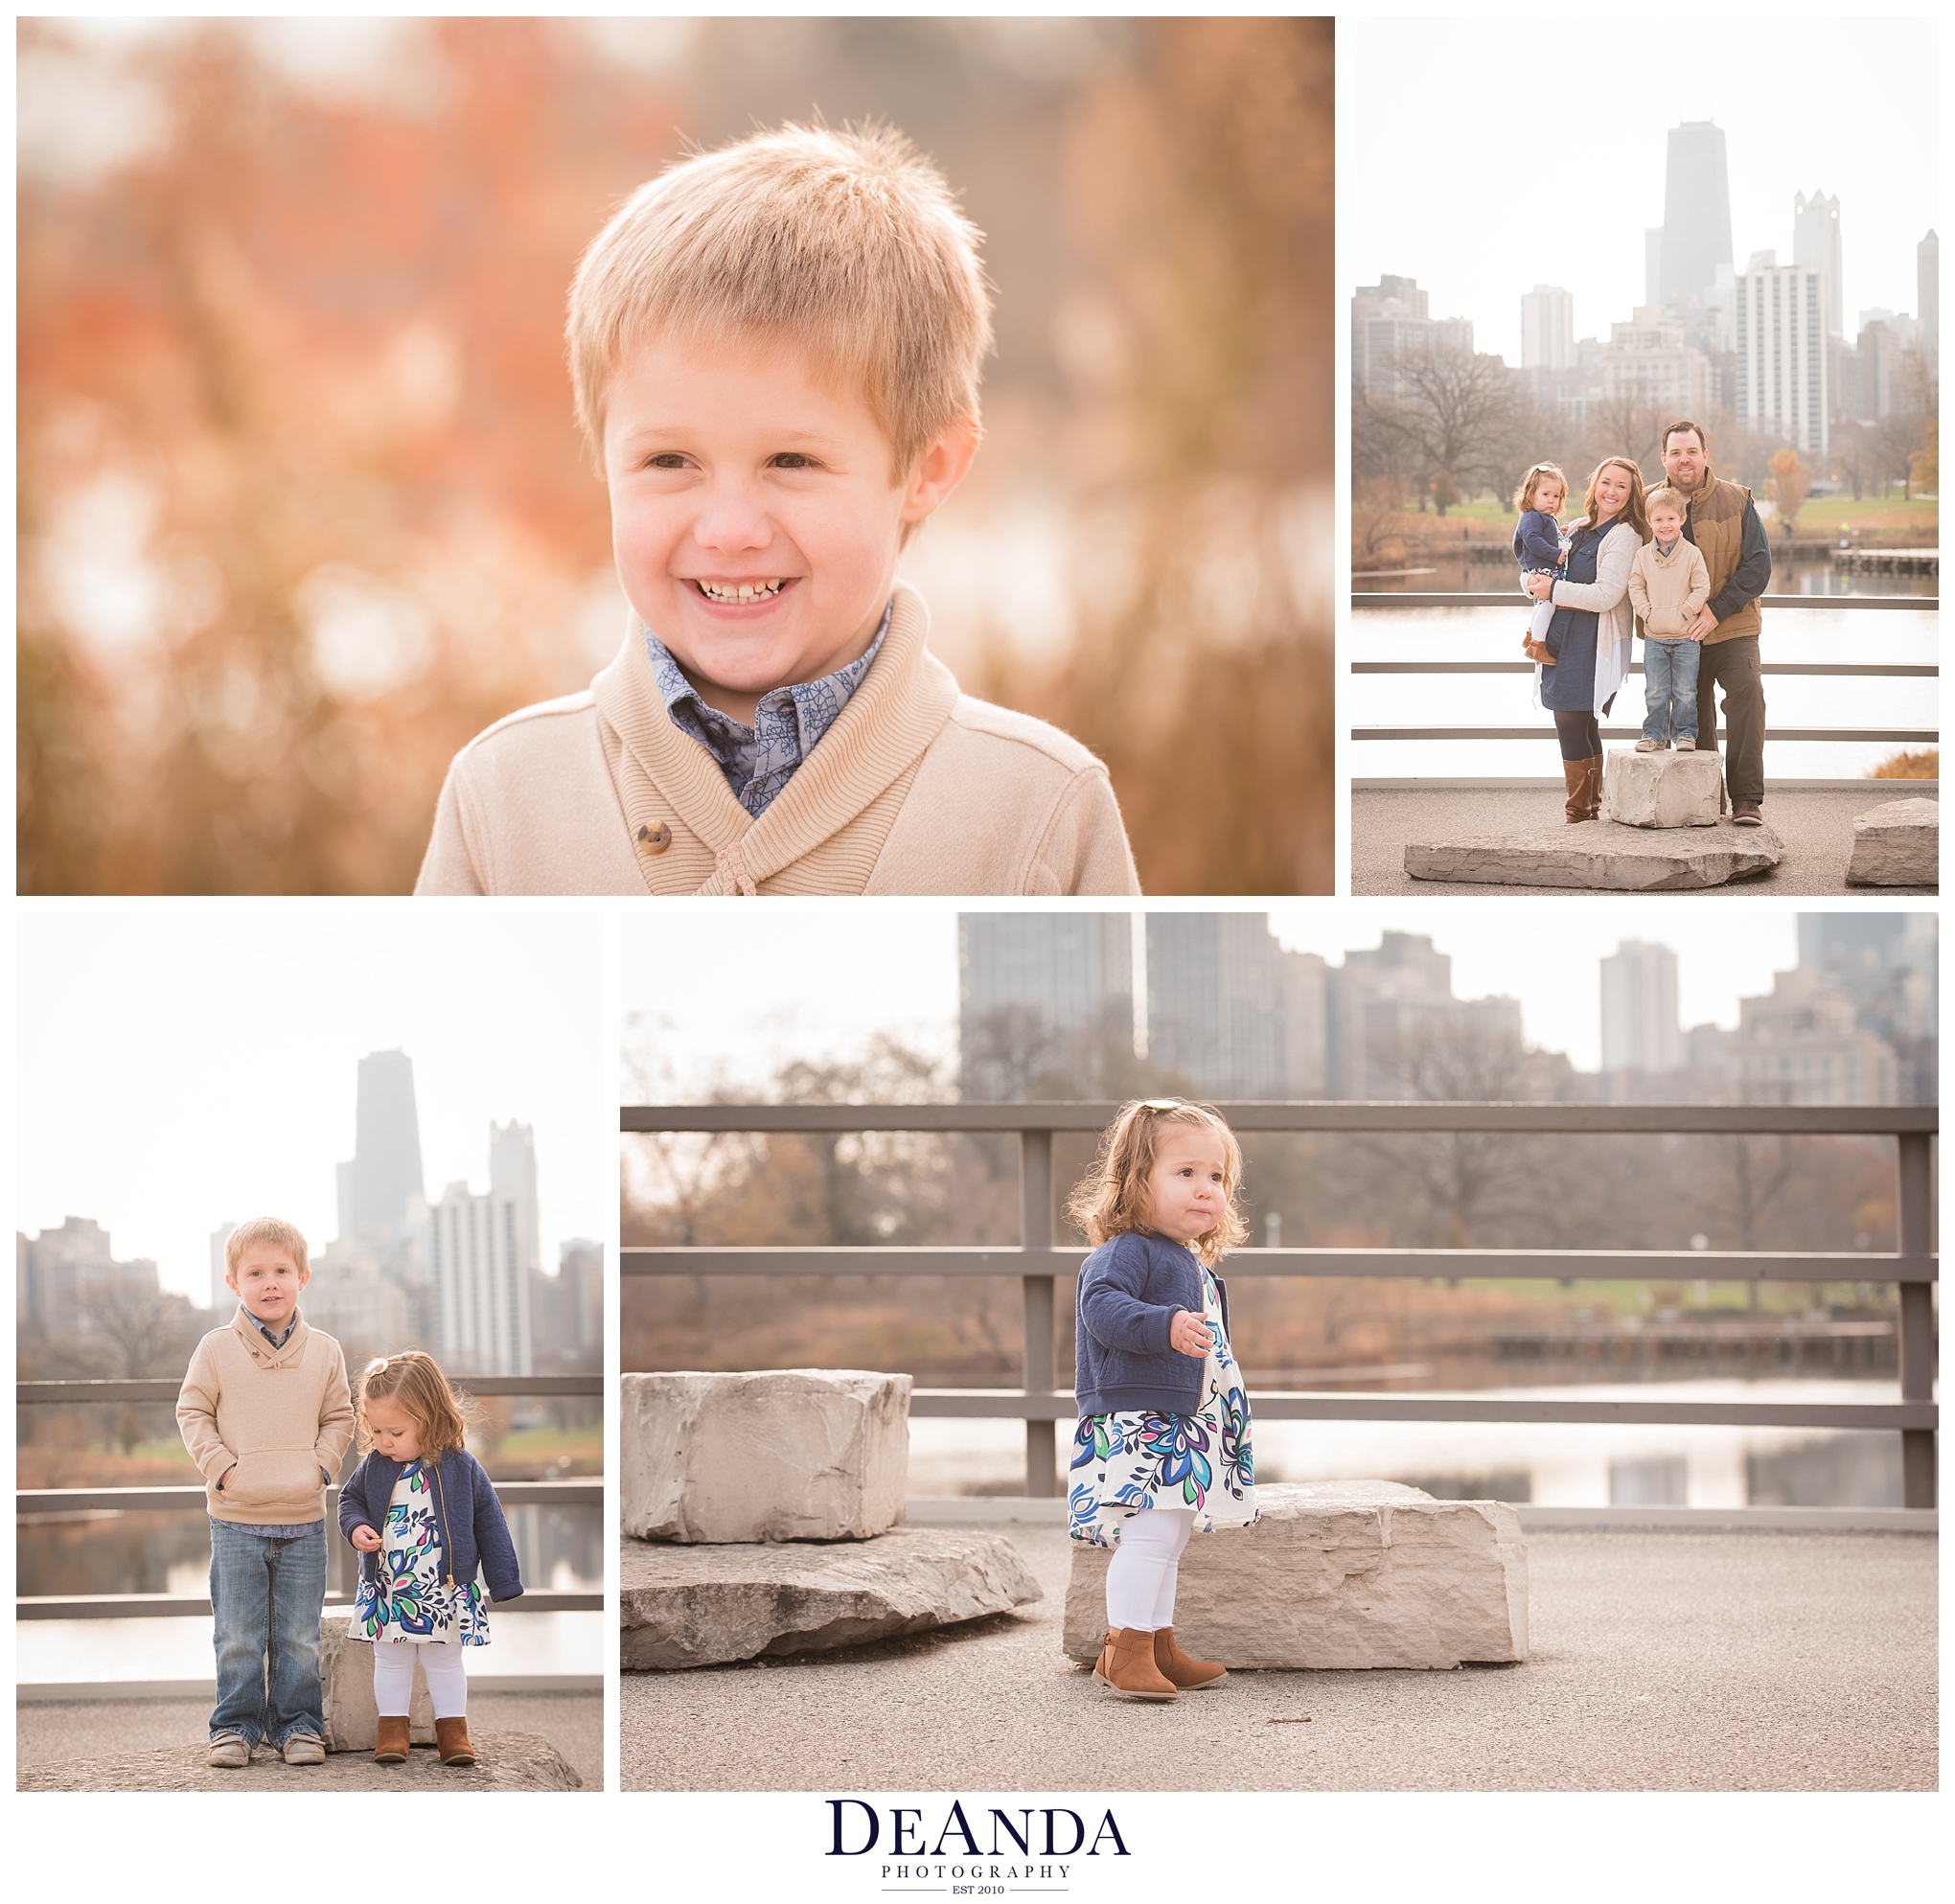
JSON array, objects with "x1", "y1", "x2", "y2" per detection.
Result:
[{"x1": 176, "y1": 1216, "x2": 354, "y2": 1767}]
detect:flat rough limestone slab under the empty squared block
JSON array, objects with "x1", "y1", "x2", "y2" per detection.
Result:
[{"x1": 618, "y1": 1526, "x2": 1044, "y2": 1671}]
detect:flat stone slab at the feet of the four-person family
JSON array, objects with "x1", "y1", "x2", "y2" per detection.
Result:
[{"x1": 1406, "y1": 819, "x2": 1785, "y2": 893}]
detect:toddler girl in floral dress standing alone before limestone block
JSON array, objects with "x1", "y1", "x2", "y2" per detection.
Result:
[{"x1": 1068, "y1": 1099, "x2": 1257, "y2": 1699}]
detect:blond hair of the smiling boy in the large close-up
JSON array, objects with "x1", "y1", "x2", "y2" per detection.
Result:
[{"x1": 567, "y1": 126, "x2": 991, "y2": 483}]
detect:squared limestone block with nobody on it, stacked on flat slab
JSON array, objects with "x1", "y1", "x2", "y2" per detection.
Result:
[{"x1": 618, "y1": 1368, "x2": 909, "y2": 1545}]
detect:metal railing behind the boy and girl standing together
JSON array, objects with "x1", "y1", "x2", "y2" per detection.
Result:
[{"x1": 13, "y1": 1374, "x2": 604, "y2": 1620}]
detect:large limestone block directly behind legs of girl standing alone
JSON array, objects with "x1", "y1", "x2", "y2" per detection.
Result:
[{"x1": 1066, "y1": 1481, "x2": 1527, "y2": 1667}]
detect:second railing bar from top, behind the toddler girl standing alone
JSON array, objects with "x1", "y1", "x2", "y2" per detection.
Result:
[{"x1": 620, "y1": 1243, "x2": 1940, "y2": 1282}]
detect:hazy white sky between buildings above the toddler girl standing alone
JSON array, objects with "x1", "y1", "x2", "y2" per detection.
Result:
[{"x1": 622, "y1": 899, "x2": 1845, "y2": 1089}]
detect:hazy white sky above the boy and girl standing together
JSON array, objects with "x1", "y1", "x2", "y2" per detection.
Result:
[{"x1": 15, "y1": 906, "x2": 602, "y2": 1302}]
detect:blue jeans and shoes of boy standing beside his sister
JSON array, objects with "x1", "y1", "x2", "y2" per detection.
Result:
[{"x1": 211, "y1": 1519, "x2": 327, "y2": 1752}]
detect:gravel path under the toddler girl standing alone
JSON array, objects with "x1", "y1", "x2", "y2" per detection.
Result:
[{"x1": 620, "y1": 1526, "x2": 1938, "y2": 1793}]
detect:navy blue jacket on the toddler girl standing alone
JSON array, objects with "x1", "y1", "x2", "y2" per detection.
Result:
[{"x1": 1073, "y1": 1229, "x2": 1228, "y2": 1415}]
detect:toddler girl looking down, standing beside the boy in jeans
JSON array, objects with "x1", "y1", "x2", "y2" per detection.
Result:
[{"x1": 340, "y1": 1349, "x2": 522, "y2": 1765}]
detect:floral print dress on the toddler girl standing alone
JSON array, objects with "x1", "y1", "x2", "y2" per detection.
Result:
[{"x1": 1068, "y1": 1263, "x2": 1257, "y2": 1547}]
